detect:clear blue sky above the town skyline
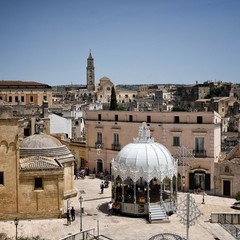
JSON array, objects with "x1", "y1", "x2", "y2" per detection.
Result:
[{"x1": 0, "y1": 0, "x2": 240, "y2": 86}]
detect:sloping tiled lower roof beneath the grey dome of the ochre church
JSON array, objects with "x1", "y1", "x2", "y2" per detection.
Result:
[{"x1": 19, "y1": 156, "x2": 62, "y2": 170}]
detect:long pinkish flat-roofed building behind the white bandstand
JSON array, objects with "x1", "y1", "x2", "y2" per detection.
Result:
[{"x1": 86, "y1": 111, "x2": 221, "y2": 193}]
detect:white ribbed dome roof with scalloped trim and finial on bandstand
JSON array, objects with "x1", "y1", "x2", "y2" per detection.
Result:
[{"x1": 112, "y1": 122, "x2": 178, "y2": 182}]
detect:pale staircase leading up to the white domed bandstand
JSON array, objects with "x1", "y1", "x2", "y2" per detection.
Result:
[{"x1": 149, "y1": 204, "x2": 169, "y2": 223}]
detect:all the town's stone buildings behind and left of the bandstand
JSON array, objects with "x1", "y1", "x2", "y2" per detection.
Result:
[{"x1": 0, "y1": 53, "x2": 240, "y2": 219}]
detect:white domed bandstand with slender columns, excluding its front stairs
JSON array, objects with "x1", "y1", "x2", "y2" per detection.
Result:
[{"x1": 112, "y1": 123, "x2": 178, "y2": 218}]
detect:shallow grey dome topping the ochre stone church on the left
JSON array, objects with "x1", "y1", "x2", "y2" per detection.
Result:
[{"x1": 20, "y1": 133, "x2": 62, "y2": 148}]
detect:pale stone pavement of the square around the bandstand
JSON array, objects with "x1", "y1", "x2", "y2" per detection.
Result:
[{"x1": 0, "y1": 177, "x2": 238, "y2": 240}]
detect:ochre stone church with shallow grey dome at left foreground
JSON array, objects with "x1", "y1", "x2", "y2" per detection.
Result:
[{"x1": 0, "y1": 108, "x2": 77, "y2": 219}]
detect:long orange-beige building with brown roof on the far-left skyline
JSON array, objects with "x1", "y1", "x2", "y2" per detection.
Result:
[{"x1": 0, "y1": 80, "x2": 52, "y2": 106}]
